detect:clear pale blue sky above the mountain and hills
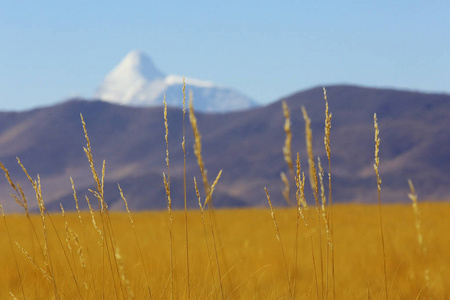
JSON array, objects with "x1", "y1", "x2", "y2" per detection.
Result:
[{"x1": 0, "y1": 0, "x2": 450, "y2": 110}]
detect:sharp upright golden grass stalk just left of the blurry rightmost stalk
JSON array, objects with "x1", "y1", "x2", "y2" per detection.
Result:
[{"x1": 373, "y1": 114, "x2": 389, "y2": 300}]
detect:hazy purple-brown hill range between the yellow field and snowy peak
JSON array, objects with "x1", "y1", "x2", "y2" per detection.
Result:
[{"x1": 0, "y1": 86, "x2": 450, "y2": 211}]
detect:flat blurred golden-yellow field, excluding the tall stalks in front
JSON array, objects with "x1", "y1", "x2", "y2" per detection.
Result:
[{"x1": 0, "y1": 203, "x2": 450, "y2": 299}]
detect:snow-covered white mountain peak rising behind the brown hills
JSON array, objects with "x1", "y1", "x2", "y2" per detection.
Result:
[{"x1": 94, "y1": 51, "x2": 257, "y2": 112}]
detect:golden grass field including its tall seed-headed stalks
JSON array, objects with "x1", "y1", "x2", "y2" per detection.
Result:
[{"x1": 0, "y1": 89, "x2": 450, "y2": 299}]
